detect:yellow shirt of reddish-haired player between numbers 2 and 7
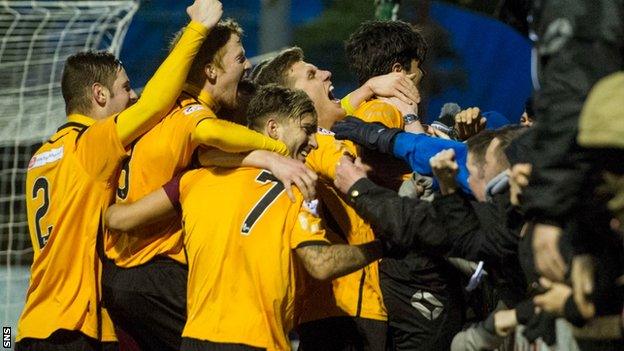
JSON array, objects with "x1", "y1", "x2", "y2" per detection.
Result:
[{"x1": 105, "y1": 85, "x2": 288, "y2": 267}]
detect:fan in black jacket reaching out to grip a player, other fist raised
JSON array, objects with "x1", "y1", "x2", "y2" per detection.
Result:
[{"x1": 336, "y1": 128, "x2": 526, "y2": 306}]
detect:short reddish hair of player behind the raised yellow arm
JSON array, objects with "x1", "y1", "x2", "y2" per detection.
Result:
[{"x1": 169, "y1": 18, "x2": 243, "y2": 84}]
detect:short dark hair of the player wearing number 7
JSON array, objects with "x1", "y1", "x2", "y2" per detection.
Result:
[{"x1": 247, "y1": 84, "x2": 317, "y2": 131}]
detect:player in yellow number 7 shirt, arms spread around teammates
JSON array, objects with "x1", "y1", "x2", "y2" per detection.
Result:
[{"x1": 107, "y1": 85, "x2": 381, "y2": 350}]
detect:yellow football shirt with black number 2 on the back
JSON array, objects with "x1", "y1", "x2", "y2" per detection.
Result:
[{"x1": 17, "y1": 114, "x2": 126, "y2": 341}]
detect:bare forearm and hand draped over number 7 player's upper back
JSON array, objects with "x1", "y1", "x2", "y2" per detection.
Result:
[{"x1": 198, "y1": 149, "x2": 318, "y2": 203}]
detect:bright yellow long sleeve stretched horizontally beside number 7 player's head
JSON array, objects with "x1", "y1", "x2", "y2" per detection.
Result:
[{"x1": 192, "y1": 118, "x2": 288, "y2": 156}]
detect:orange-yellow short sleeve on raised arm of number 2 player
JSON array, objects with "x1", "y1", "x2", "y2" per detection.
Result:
[{"x1": 75, "y1": 117, "x2": 126, "y2": 182}]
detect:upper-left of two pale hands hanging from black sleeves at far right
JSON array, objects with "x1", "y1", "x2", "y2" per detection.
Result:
[{"x1": 533, "y1": 223, "x2": 568, "y2": 282}]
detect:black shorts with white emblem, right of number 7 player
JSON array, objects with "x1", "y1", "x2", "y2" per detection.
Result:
[{"x1": 380, "y1": 273, "x2": 464, "y2": 351}]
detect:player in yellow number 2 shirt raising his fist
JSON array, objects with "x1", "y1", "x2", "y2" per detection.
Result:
[{"x1": 16, "y1": 0, "x2": 222, "y2": 350}]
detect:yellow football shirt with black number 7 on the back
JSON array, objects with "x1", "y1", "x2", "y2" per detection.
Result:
[{"x1": 180, "y1": 168, "x2": 327, "y2": 350}]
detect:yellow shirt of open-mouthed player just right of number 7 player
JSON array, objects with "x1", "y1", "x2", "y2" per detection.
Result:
[{"x1": 298, "y1": 128, "x2": 387, "y2": 323}]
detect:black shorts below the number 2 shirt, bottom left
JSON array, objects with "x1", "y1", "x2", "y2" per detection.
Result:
[{"x1": 15, "y1": 329, "x2": 119, "y2": 351}]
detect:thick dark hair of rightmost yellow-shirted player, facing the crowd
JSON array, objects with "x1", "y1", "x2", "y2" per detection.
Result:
[{"x1": 345, "y1": 21, "x2": 427, "y2": 84}]
